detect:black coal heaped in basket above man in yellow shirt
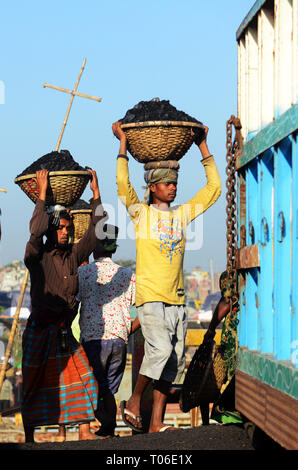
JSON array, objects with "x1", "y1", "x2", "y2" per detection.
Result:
[{"x1": 120, "y1": 98, "x2": 201, "y2": 124}]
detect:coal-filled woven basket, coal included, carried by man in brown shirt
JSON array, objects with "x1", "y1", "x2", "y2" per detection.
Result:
[{"x1": 15, "y1": 150, "x2": 91, "y2": 207}]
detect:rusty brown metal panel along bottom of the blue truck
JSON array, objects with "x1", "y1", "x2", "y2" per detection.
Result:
[{"x1": 235, "y1": 370, "x2": 298, "y2": 450}]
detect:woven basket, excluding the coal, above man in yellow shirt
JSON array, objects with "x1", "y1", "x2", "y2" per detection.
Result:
[{"x1": 121, "y1": 121, "x2": 204, "y2": 163}]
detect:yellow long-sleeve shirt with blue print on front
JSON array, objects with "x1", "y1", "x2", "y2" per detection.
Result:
[{"x1": 117, "y1": 157, "x2": 221, "y2": 307}]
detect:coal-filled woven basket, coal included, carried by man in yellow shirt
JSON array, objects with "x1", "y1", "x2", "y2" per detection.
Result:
[{"x1": 120, "y1": 98, "x2": 204, "y2": 163}]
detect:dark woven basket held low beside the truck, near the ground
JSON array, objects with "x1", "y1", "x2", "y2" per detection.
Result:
[{"x1": 179, "y1": 341, "x2": 226, "y2": 413}]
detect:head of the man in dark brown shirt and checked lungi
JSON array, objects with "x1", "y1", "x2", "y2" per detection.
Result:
[{"x1": 47, "y1": 208, "x2": 72, "y2": 249}]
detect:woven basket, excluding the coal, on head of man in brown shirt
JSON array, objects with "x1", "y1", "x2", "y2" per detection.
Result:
[{"x1": 14, "y1": 170, "x2": 91, "y2": 206}]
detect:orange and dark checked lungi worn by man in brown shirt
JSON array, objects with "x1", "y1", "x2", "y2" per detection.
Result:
[{"x1": 22, "y1": 322, "x2": 98, "y2": 427}]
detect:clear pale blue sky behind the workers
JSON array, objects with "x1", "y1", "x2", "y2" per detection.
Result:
[{"x1": 0, "y1": 0, "x2": 255, "y2": 272}]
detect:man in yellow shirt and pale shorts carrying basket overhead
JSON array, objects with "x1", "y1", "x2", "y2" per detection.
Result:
[{"x1": 113, "y1": 122, "x2": 221, "y2": 432}]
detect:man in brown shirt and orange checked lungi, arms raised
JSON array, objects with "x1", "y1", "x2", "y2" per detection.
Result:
[{"x1": 22, "y1": 170, "x2": 104, "y2": 442}]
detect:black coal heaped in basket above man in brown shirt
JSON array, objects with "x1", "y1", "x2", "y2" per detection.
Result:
[{"x1": 18, "y1": 150, "x2": 86, "y2": 177}]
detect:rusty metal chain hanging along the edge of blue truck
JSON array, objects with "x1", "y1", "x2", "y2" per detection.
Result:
[{"x1": 226, "y1": 115, "x2": 243, "y2": 300}]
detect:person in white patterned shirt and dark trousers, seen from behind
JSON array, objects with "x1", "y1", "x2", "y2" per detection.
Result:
[{"x1": 77, "y1": 224, "x2": 140, "y2": 437}]
